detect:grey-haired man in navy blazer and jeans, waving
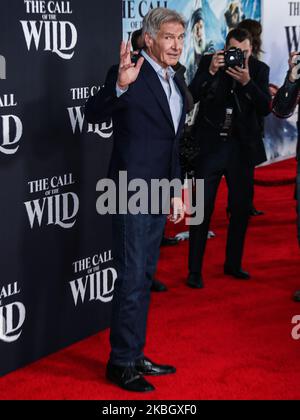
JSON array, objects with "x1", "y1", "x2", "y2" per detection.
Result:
[{"x1": 86, "y1": 8, "x2": 186, "y2": 392}]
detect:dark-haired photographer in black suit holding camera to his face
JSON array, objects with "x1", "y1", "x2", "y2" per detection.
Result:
[{"x1": 187, "y1": 29, "x2": 270, "y2": 288}]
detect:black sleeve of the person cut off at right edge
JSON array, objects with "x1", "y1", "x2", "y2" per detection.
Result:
[{"x1": 272, "y1": 74, "x2": 300, "y2": 118}]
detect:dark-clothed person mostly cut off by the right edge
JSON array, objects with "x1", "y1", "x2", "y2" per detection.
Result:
[{"x1": 272, "y1": 52, "x2": 300, "y2": 302}]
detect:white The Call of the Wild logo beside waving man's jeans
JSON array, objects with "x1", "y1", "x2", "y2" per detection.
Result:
[{"x1": 69, "y1": 250, "x2": 117, "y2": 306}]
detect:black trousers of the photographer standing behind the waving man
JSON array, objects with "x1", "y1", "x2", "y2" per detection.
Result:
[{"x1": 189, "y1": 139, "x2": 254, "y2": 273}]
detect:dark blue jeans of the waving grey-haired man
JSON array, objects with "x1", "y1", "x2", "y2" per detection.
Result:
[{"x1": 110, "y1": 214, "x2": 166, "y2": 366}]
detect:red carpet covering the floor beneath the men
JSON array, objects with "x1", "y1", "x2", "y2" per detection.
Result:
[{"x1": 0, "y1": 160, "x2": 300, "y2": 400}]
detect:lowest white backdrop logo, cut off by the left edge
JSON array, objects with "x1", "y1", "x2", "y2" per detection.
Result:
[{"x1": 0, "y1": 282, "x2": 26, "y2": 343}]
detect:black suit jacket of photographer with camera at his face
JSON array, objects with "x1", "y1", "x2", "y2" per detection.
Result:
[{"x1": 189, "y1": 55, "x2": 271, "y2": 166}]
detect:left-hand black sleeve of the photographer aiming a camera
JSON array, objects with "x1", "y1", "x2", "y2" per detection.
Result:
[{"x1": 189, "y1": 55, "x2": 216, "y2": 104}]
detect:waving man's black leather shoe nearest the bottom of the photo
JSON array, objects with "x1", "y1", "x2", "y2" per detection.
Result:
[{"x1": 106, "y1": 362, "x2": 155, "y2": 392}]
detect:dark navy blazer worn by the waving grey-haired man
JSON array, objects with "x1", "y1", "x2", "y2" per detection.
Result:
[{"x1": 85, "y1": 60, "x2": 186, "y2": 183}]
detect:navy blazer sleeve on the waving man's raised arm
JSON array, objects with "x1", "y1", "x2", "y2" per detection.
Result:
[{"x1": 85, "y1": 66, "x2": 126, "y2": 124}]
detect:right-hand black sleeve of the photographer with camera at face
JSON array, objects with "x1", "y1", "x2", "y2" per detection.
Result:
[{"x1": 241, "y1": 63, "x2": 271, "y2": 117}]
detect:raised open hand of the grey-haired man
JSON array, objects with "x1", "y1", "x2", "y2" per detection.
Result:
[{"x1": 117, "y1": 41, "x2": 144, "y2": 90}]
